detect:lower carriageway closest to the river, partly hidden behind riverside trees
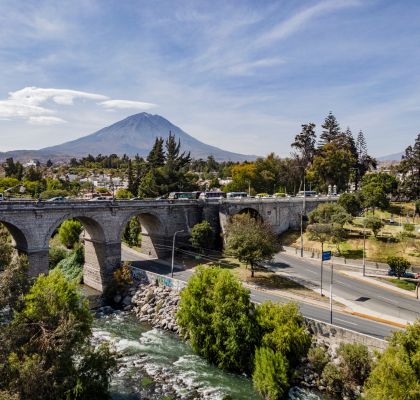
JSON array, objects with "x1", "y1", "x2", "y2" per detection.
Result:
[{"x1": 122, "y1": 247, "x2": 398, "y2": 339}]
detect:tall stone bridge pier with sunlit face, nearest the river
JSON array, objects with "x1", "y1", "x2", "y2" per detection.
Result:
[{"x1": 83, "y1": 237, "x2": 121, "y2": 292}]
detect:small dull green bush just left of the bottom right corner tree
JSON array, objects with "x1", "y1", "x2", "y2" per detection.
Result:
[{"x1": 337, "y1": 343, "x2": 372, "y2": 385}]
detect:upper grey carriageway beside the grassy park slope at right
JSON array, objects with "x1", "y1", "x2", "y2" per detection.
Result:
[{"x1": 271, "y1": 253, "x2": 420, "y2": 321}]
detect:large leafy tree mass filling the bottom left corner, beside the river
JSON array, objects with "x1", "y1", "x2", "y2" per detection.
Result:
[{"x1": 0, "y1": 270, "x2": 116, "y2": 400}]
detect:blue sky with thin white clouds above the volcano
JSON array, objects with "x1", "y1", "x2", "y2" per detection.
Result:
[{"x1": 0, "y1": 0, "x2": 420, "y2": 156}]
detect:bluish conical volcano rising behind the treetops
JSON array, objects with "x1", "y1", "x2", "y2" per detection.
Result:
[{"x1": 39, "y1": 113, "x2": 255, "y2": 161}]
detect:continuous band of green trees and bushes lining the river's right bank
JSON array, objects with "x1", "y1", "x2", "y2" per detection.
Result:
[{"x1": 177, "y1": 266, "x2": 420, "y2": 400}]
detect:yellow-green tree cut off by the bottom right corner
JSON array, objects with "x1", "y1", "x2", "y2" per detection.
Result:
[{"x1": 365, "y1": 320, "x2": 420, "y2": 400}]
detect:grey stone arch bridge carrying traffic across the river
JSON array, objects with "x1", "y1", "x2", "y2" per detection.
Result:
[{"x1": 0, "y1": 198, "x2": 330, "y2": 291}]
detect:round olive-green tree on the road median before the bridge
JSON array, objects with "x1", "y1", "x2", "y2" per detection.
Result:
[{"x1": 225, "y1": 214, "x2": 278, "y2": 277}]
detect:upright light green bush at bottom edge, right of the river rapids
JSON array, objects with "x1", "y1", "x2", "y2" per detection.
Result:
[{"x1": 252, "y1": 347, "x2": 289, "y2": 400}]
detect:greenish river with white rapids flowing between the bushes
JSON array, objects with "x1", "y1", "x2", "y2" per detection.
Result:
[{"x1": 93, "y1": 312, "x2": 332, "y2": 400}]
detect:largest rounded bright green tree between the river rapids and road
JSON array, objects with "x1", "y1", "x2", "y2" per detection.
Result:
[{"x1": 177, "y1": 267, "x2": 257, "y2": 372}]
